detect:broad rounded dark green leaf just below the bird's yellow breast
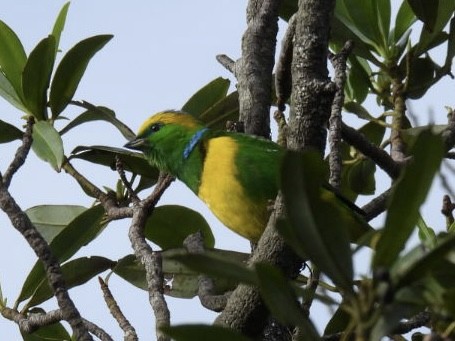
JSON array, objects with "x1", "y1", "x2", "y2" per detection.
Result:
[{"x1": 144, "y1": 205, "x2": 215, "y2": 249}]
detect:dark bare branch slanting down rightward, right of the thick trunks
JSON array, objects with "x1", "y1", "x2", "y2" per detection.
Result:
[{"x1": 341, "y1": 123, "x2": 400, "y2": 179}]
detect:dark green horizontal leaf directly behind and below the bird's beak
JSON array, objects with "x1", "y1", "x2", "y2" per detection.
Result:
[{"x1": 70, "y1": 146, "x2": 159, "y2": 181}]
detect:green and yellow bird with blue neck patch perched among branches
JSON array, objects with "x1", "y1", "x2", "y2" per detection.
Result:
[{"x1": 125, "y1": 111, "x2": 285, "y2": 241}]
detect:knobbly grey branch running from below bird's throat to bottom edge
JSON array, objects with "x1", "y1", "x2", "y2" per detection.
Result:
[{"x1": 128, "y1": 173, "x2": 173, "y2": 341}]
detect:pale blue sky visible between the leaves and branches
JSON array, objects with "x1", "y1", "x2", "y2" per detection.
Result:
[{"x1": 0, "y1": 0, "x2": 454, "y2": 340}]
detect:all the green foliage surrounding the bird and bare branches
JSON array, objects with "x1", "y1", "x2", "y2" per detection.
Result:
[{"x1": 0, "y1": 0, "x2": 455, "y2": 340}]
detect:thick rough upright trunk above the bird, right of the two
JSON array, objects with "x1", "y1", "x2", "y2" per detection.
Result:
[{"x1": 288, "y1": 0, "x2": 336, "y2": 155}]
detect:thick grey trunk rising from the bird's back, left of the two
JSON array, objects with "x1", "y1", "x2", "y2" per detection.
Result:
[{"x1": 234, "y1": 0, "x2": 281, "y2": 138}]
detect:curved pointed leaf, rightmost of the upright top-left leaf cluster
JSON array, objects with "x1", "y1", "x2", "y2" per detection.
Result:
[{"x1": 50, "y1": 35, "x2": 113, "y2": 119}]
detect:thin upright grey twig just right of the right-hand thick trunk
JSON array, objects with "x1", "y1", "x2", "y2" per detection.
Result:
[{"x1": 329, "y1": 40, "x2": 354, "y2": 189}]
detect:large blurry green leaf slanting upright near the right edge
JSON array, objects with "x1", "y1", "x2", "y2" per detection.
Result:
[{"x1": 373, "y1": 130, "x2": 444, "y2": 269}]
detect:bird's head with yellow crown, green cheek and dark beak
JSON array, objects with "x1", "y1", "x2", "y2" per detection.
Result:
[{"x1": 125, "y1": 111, "x2": 206, "y2": 174}]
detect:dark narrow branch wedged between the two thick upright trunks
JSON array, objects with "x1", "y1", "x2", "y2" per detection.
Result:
[{"x1": 275, "y1": 14, "x2": 296, "y2": 111}]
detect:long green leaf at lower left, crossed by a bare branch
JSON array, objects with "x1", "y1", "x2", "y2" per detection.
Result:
[{"x1": 17, "y1": 205, "x2": 106, "y2": 302}]
